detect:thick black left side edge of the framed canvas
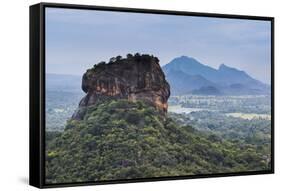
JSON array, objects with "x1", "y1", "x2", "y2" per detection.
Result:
[{"x1": 29, "y1": 4, "x2": 43, "y2": 188}]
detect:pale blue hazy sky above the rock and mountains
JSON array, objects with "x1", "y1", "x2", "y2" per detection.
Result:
[{"x1": 46, "y1": 8, "x2": 271, "y2": 83}]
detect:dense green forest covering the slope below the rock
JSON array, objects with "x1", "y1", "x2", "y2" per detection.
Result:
[{"x1": 46, "y1": 100, "x2": 271, "y2": 183}]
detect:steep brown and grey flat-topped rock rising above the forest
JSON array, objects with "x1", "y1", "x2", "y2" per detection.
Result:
[{"x1": 72, "y1": 53, "x2": 170, "y2": 120}]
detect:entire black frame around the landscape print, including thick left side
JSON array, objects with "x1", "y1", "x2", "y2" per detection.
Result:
[{"x1": 29, "y1": 3, "x2": 275, "y2": 188}]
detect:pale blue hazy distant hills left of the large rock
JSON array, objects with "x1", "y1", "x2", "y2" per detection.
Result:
[{"x1": 46, "y1": 73, "x2": 82, "y2": 92}]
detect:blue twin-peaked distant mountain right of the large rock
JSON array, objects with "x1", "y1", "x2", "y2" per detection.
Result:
[{"x1": 163, "y1": 56, "x2": 270, "y2": 95}]
